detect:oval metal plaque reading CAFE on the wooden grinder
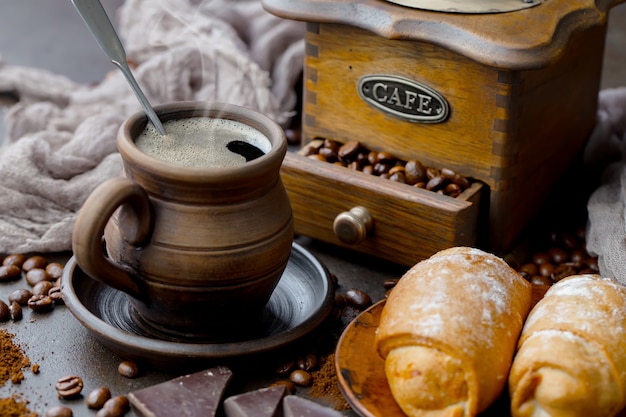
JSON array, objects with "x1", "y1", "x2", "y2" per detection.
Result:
[{"x1": 357, "y1": 74, "x2": 449, "y2": 123}]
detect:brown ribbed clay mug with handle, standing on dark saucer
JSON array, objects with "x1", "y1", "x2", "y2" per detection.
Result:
[{"x1": 72, "y1": 102, "x2": 293, "y2": 340}]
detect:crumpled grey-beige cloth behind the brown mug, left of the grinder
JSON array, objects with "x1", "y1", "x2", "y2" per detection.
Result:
[{"x1": 0, "y1": 0, "x2": 305, "y2": 253}]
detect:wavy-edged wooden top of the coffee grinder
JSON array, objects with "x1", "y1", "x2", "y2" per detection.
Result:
[{"x1": 262, "y1": 0, "x2": 626, "y2": 70}]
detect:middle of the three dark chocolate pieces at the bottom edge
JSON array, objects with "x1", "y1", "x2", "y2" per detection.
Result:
[{"x1": 224, "y1": 385, "x2": 286, "y2": 417}]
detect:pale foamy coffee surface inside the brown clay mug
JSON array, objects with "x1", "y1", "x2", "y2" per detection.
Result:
[{"x1": 135, "y1": 117, "x2": 271, "y2": 168}]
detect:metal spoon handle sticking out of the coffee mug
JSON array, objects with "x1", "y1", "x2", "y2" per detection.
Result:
[{"x1": 72, "y1": 0, "x2": 167, "y2": 135}]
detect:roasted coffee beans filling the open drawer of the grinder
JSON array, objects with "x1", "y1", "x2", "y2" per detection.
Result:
[{"x1": 299, "y1": 138, "x2": 472, "y2": 197}]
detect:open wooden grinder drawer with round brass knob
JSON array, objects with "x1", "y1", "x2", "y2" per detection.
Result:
[{"x1": 281, "y1": 152, "x2": 486, "y2": 266}]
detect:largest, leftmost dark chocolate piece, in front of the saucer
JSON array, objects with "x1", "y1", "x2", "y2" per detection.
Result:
[{"x1": 128, "y1": 366, "x2": 233, "y2": 417}]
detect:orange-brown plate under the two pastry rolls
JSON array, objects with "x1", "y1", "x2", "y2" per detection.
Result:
[{"x1": 335, "y1": 286, "x2": 547, "y2": 417}]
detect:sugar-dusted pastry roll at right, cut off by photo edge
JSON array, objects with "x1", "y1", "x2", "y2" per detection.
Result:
[{"x1": 509, "y1": 275, "x2": 626, "y2": 417}]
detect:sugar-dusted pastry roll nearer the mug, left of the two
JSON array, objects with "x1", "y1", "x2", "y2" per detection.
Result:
[{"x1": 375, "y1": 247, "x2": 532, "y2": 417}]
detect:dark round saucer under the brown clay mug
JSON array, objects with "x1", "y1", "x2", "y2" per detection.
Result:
[{"x1": 62, "y1": 243, "x2": 334, "y2": 368}]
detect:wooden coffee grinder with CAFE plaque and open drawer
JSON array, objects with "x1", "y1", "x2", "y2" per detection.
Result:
[{"x1": 263, "y1": 0, "x2": 623, "y2": 265}]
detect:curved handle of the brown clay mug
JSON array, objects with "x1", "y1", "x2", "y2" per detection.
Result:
[{"x1": 72, "y1": 177, "x2": 152, "y2": 299}]
